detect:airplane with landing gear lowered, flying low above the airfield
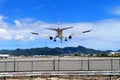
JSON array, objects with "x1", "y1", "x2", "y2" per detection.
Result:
[{"x1": 31, "y1": 26, "x2": 92, "y2": 43}]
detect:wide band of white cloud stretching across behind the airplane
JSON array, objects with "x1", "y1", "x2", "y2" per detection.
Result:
[{"x1": 0, "y1": 16, "x2": 120, "y2": 50}]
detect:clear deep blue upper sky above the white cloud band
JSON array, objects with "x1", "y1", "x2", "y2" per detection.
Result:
[{"x1": 0, "y1": 0, "x2": 120, "y2": 22}]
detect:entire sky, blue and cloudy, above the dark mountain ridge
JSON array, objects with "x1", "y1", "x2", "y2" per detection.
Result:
[{"x1": 0, "y1": 0, "x2": 120, "y2": 50}]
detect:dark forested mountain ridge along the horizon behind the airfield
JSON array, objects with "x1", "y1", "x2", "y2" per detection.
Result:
[{"x1": 0, "y1": 46, "x2": 120, "y2": 56}]
